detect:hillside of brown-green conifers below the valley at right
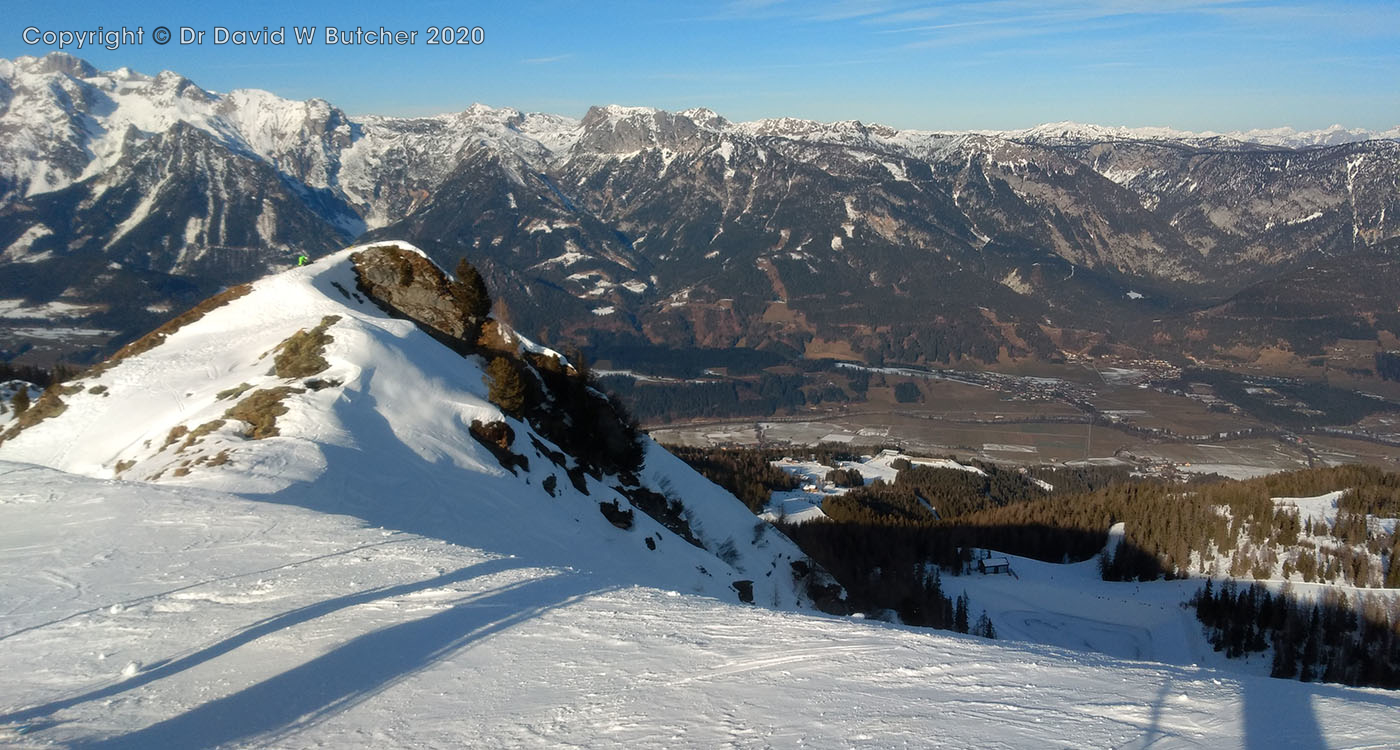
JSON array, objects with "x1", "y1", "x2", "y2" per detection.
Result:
[{"x1": 678, "y1": 448, "x2": 1400, "y2": 687}]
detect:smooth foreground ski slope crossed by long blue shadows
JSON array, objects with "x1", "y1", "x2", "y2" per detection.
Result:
[{"x1": 0, "y1": 463, "x2": 1400, "y2": 749}]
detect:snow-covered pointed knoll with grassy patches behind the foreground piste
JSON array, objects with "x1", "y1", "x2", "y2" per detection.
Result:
[{"x1": 0, "y1": 248, "x2": 808, "y2": 607}]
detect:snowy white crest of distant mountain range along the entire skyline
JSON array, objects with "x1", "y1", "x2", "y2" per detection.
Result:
[{"x1": 0, "y1": 52, "x2": 1400, "y2": 211}]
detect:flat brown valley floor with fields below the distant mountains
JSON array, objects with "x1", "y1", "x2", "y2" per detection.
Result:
[{"x1": 648, "y1": 365, "x2": 1400, "y2": 477}]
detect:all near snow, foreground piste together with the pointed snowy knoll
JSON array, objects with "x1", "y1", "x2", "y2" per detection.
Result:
[{"x1": 0, "y1": 243, "x2": 1400, "y2": 749}]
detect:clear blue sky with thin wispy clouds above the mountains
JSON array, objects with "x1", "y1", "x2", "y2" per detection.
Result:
[{"x1": 0, "y1": 0, "x2": 1400, "y2": 130}]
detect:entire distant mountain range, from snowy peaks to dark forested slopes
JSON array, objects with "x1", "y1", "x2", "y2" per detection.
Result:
[{"x1": 0, "y1": 53, "x2": 1400, "y2": 361}]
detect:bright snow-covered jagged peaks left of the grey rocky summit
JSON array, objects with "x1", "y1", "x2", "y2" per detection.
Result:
[{"x1": 0, "y1": 53, "x2": 578, "y2": 219}]
